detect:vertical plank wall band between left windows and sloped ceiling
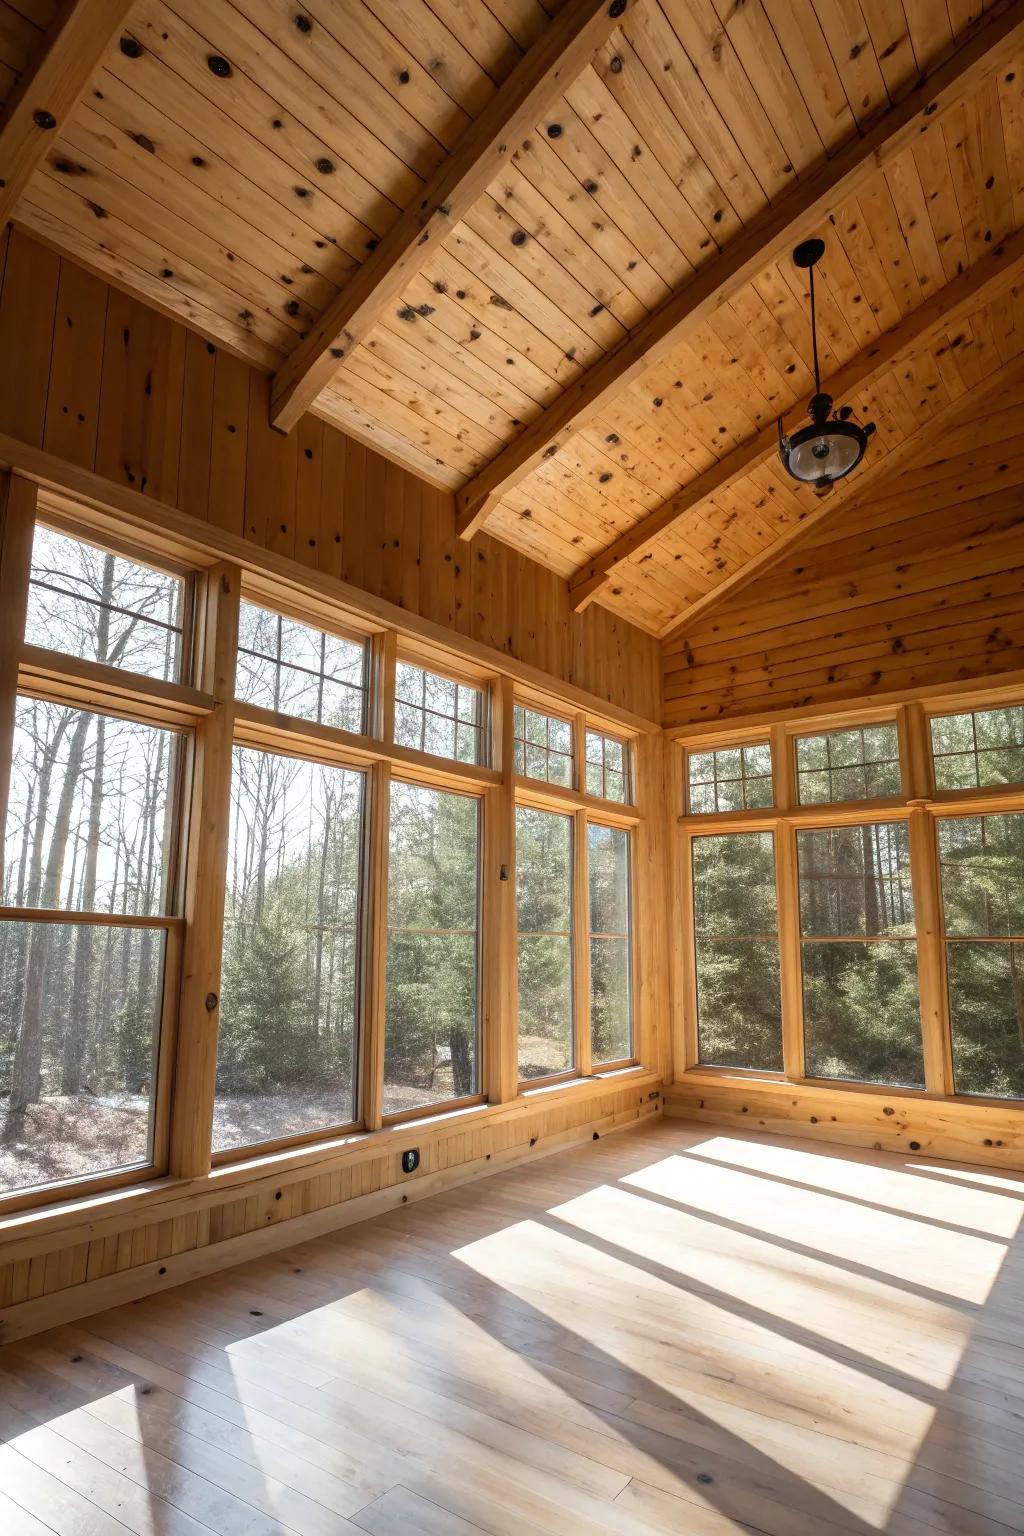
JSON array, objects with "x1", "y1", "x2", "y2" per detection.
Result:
[{"x1": 0, "y1": 230, "x2": 660, "y2": 719}]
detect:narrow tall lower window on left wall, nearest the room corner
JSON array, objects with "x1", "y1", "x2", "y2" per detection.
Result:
[{"x1": 586, "y1": 822, "x2": 633, "y2": 1066}]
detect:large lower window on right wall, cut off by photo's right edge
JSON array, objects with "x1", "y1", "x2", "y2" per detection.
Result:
[{"x1": 938, "y1": 811, "x2": 1024, "y2": 1098}]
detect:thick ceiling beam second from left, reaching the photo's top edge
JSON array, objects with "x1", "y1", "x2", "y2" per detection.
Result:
[{"x1": 270, "y1": 0, "x2": 642, "y2": 432}]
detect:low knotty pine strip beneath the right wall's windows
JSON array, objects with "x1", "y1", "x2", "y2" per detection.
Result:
[{"x1": 665, "y1": 1074, "x2": 1024, "y2": 1172}]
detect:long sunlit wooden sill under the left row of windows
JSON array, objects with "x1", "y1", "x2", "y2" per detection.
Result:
[{"x1": 0, "y1": 1066, "x2": 663, "y2": 1264}]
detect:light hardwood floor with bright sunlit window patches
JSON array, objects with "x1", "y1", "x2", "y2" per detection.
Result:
[{"x1": 0, "y1": 1121, "x2": 1024, "y2": 1536}]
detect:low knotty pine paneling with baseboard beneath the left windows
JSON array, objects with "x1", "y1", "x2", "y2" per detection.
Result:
[{"x1": 0, "y1": 1077, "x2": 662, "y2": 1344}]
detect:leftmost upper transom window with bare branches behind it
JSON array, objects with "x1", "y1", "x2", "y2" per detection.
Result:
[{"x1": 25, "y1": 524, "x2": 186, "y2": 679}]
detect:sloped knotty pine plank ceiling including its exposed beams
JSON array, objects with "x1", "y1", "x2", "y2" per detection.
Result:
[{"x1": 0, "y1": 0, "x2": 1024, "y2": 634}]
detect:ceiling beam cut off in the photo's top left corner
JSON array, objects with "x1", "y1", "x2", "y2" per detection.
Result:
[{"x1": 0, "y1": 0, "x2": 132, "y2": 227}]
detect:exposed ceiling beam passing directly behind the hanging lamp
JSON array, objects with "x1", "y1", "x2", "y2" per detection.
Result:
[{"x1": 570, "y1": 229, "x2": 1024, "y2": 613}]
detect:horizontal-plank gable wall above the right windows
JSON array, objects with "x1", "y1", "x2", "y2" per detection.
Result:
[{"x1": 663, "y1": 379, "x2": 1024, "y2": 725}]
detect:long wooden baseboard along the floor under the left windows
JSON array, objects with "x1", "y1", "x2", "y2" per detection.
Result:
[{"x1": 0, "y1": 1095, "x2": 662, "y2": 1344}]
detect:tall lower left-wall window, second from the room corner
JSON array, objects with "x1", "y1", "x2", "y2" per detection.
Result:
[{"x1": 516, "y1": 805, "x2": 576, "y2": 1081}]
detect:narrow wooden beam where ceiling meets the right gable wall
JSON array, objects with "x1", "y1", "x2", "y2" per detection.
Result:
[{"x1": 660, "y1": 358, "x2": 1024, "y2": 641}]
